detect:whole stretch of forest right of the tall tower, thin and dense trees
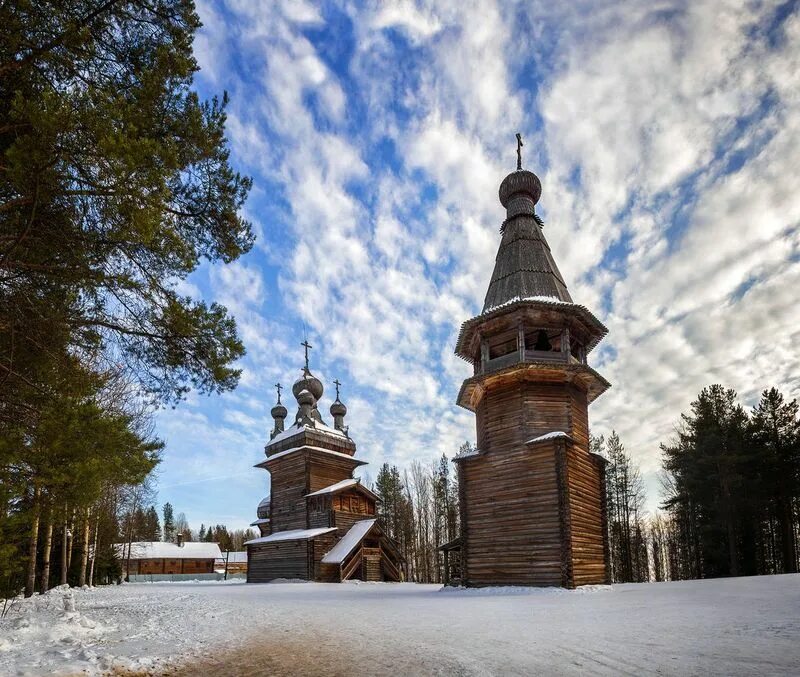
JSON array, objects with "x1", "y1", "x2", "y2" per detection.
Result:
[{"x1": 592, "y1": 385, "x2": 800, "y2": 583}]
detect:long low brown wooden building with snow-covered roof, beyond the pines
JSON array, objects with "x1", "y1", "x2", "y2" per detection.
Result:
[{"x1": 114, "y1": 541, "x2": 222, "y2": 577}]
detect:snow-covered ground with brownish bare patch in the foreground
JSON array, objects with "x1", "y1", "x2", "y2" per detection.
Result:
[{"x1": 0, "y1": 575, "x2": 800, "y2": 675}]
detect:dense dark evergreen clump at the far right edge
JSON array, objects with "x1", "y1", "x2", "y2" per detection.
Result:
[{"x1": 662, "y1": 385, "x2": 800, "y2": 579}]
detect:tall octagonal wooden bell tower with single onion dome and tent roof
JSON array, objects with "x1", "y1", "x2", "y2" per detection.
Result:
[{"x1": 443, "y1": 137, "x2": 609, "y2": 587}]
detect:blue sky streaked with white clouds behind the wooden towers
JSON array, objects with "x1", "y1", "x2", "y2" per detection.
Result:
[{"x1": 152, "y1": 0, "x2": 800, "y2": 527}]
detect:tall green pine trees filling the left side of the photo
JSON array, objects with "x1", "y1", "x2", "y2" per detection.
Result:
[{"x1": 0, "y1": 0, "x2": 253, "y2": 596}]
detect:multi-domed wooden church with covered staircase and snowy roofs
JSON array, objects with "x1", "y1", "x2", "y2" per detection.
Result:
[{"x1": 245, "y1": 342, "x2": 401, "y2": 583}]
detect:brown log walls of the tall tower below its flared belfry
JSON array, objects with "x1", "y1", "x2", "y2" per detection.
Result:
[{"x1": 459, "y1": 374, "x2": 605, "y2": 586}]
